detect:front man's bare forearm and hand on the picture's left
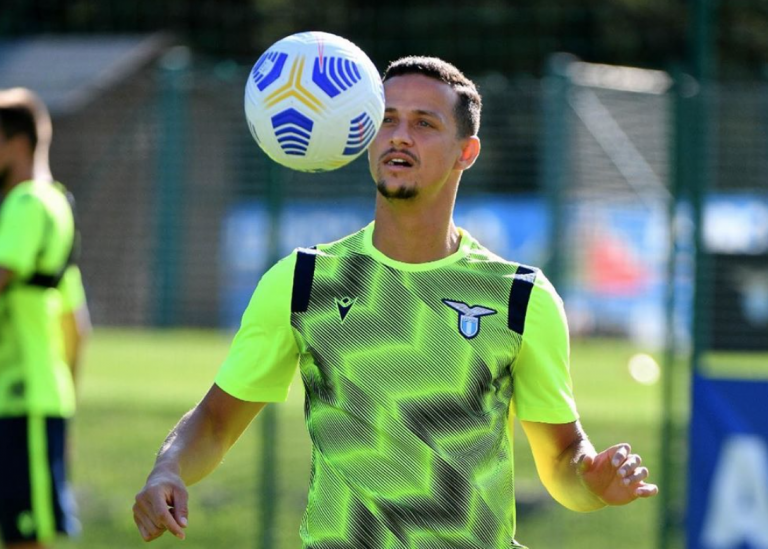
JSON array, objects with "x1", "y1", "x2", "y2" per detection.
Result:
[{"x1": 133, "y1": 385, "x2": 265, "y2": 541}]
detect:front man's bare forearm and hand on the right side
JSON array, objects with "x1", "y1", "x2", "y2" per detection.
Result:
[{"x1": 521, "y1": 421, "x2": 658, "y2": 512}]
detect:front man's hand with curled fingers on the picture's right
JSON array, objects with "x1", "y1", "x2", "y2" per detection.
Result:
[{"x1": 578, "y1": 444, "x2": 659, "y2": 505}]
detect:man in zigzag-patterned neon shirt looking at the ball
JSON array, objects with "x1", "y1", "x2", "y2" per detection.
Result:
[{"x1": 134, "y1": 58, "x2": 657, "y2": 549}]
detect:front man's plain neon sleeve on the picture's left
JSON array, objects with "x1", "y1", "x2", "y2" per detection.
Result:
[{"x1": 215, "y1": 253, "x2": 299, "y2": 402}]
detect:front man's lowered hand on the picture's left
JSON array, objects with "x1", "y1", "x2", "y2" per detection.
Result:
[{"x1": 133, "y1": 472, "x2": 189, "y2": 541}]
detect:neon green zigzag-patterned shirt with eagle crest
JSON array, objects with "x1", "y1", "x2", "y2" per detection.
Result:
[{"x1": 216, "y1": 224, "x2": 578, "y2": 549}]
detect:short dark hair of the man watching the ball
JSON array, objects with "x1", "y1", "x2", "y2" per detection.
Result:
[{"x1": 382, "y1": 56, "x2": 483, "y2": 138}]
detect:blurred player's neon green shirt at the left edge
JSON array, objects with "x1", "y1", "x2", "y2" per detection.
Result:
[{"x1": 0, "y1": 181, "x2": 85, "y2": 417}]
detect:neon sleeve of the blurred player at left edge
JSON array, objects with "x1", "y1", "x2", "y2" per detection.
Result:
[{"x1": 0, "y1": 193, "x2": 46, "y2": 278}]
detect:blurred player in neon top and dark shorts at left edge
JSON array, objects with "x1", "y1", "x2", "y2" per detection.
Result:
[{"x1": 0, "y1": 88, "x2": 89, "y2": 549}]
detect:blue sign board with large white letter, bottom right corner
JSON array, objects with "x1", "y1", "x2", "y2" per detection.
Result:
[{"x1": 687, "y1": 374, "x2": 768, "y2": 549}]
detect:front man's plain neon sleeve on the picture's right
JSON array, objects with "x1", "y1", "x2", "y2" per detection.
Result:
[{"x1": 512, "y1": 273, "x2": 579, "y2": 423}]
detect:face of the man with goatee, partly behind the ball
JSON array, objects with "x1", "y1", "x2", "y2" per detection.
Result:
[{"x1": 368, "y1": 74, "x2": 464, "y2": 199}]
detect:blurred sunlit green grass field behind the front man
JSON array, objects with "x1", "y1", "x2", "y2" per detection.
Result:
[{"x1": 56, "y1": 329, "x2": 684, "y2": 549}]
